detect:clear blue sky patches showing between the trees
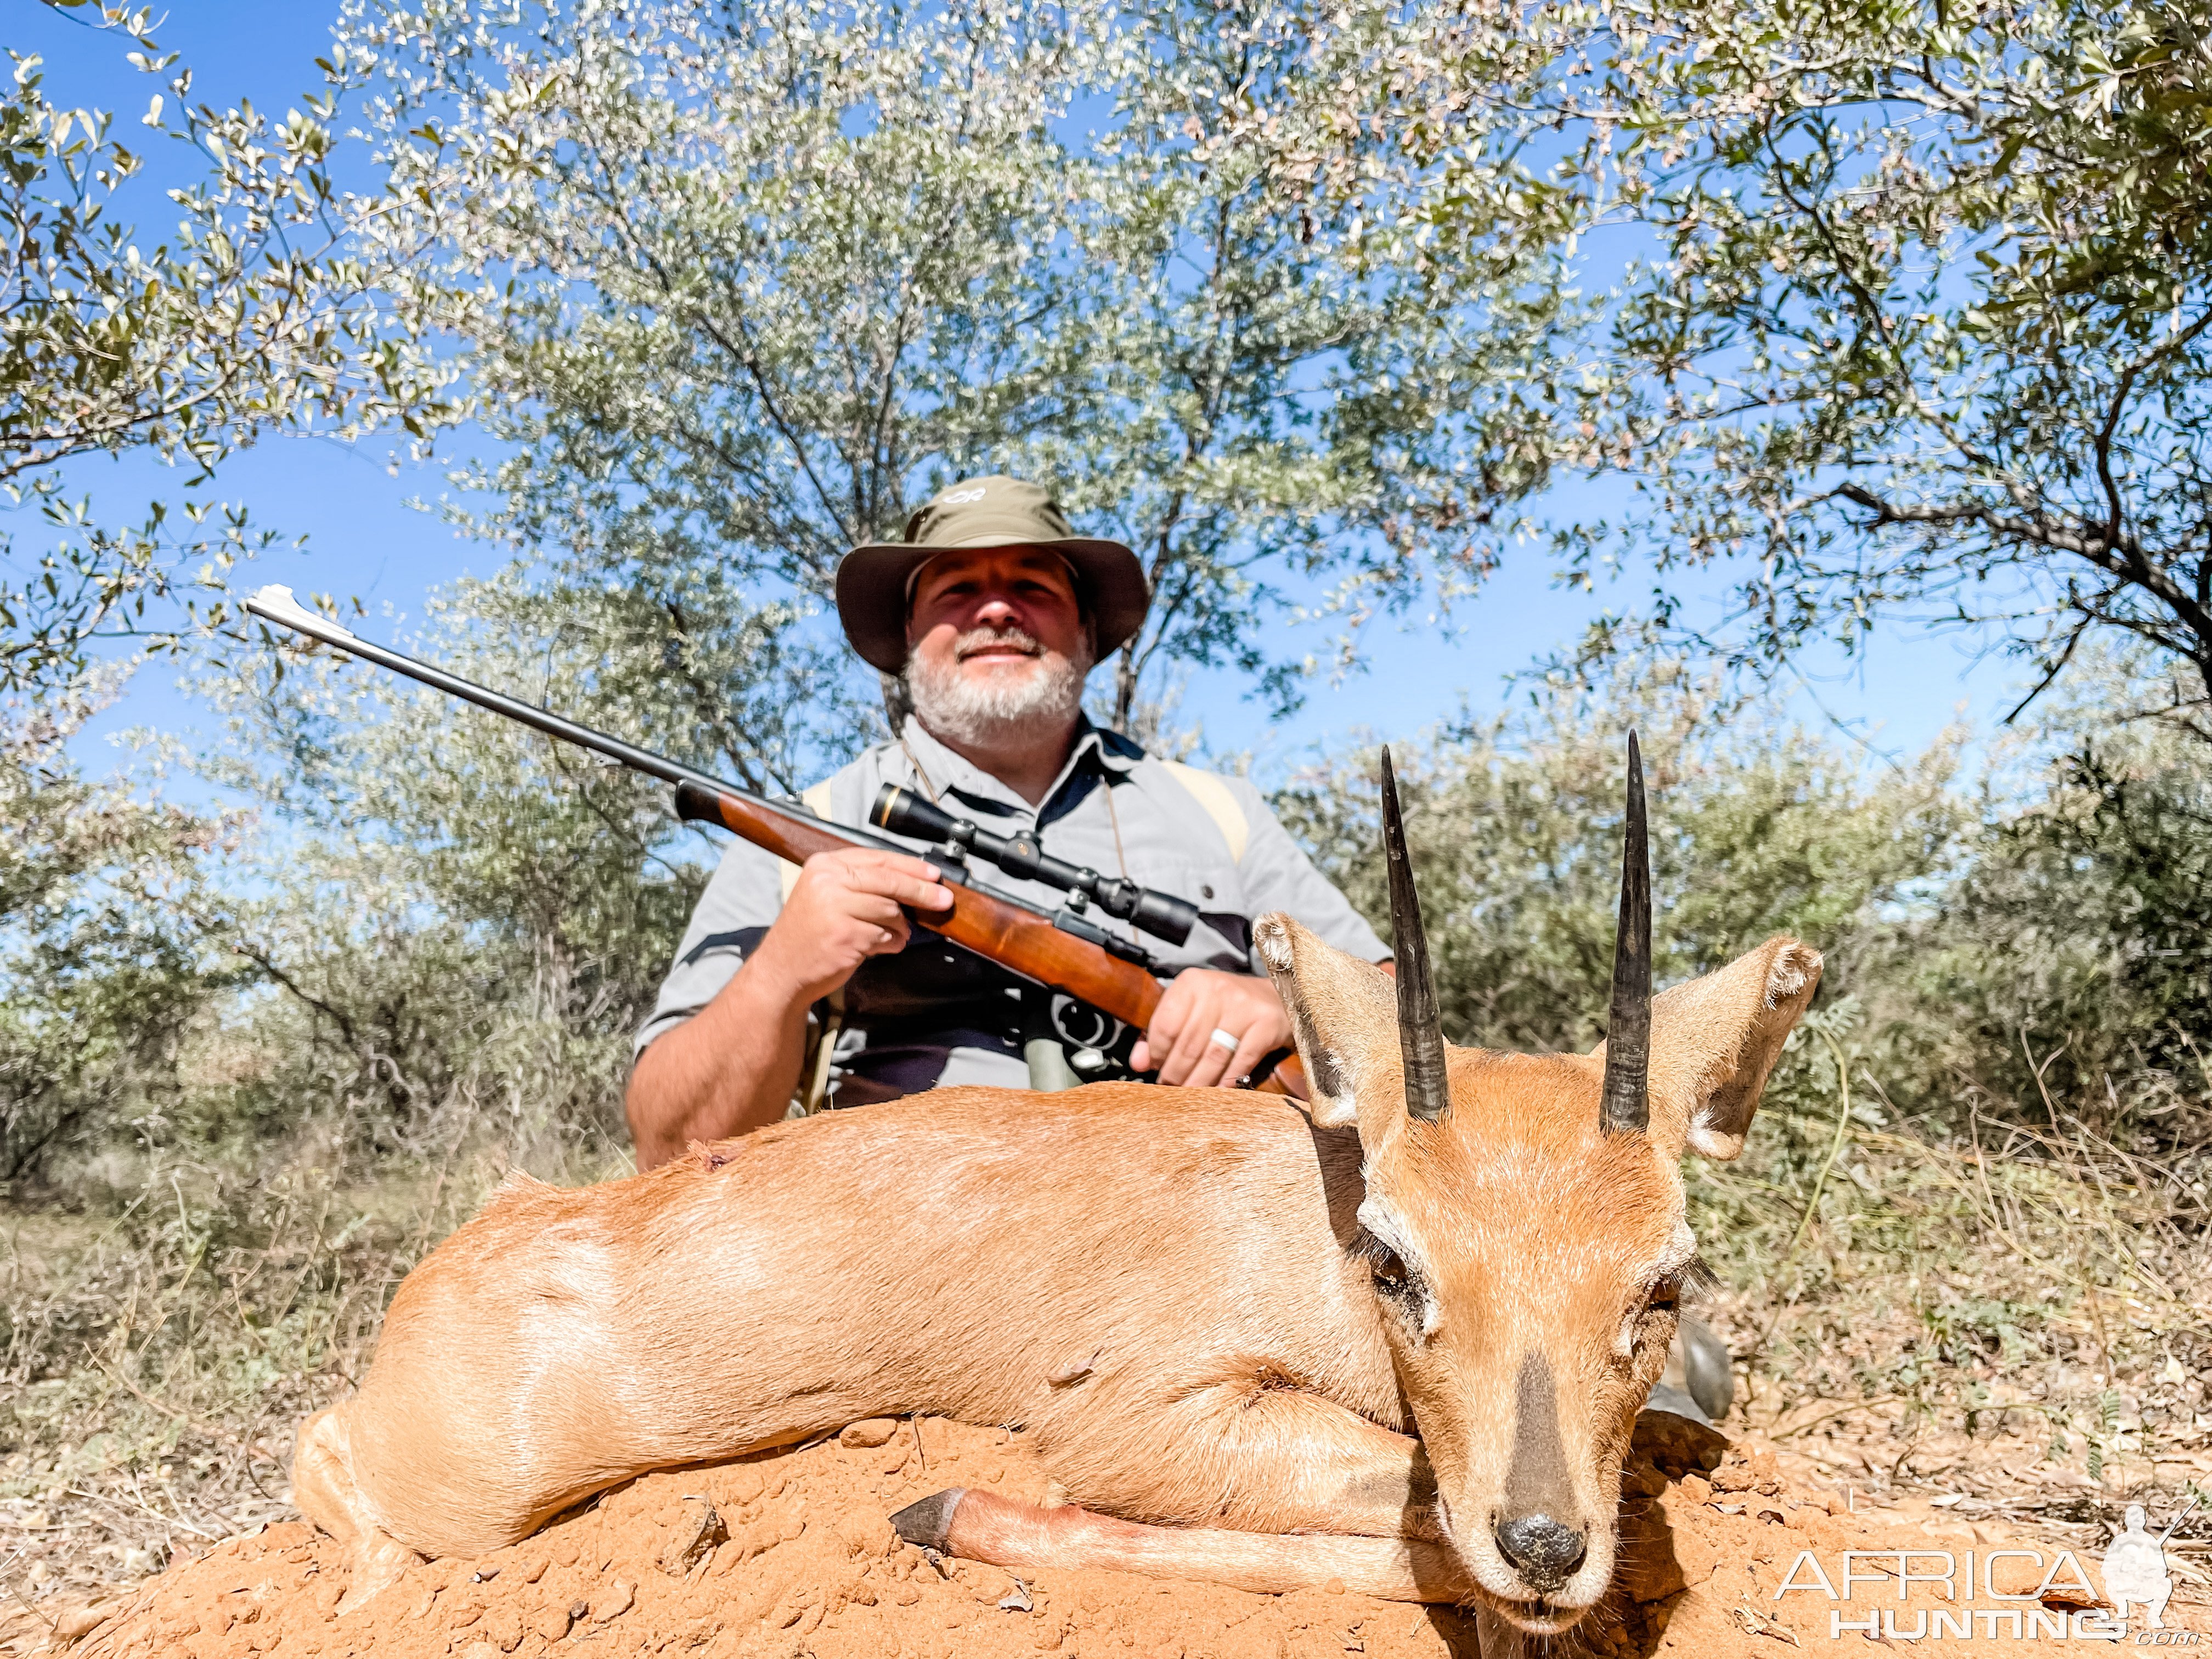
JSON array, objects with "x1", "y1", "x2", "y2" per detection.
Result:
[{"x1": 17, "y1": 0, "x2": 2019, "y2": 792}]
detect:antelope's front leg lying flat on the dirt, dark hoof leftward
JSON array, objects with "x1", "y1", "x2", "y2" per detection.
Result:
[{"x1": 891, "y1": 1489, "x2": 1475, "y2": 1601}]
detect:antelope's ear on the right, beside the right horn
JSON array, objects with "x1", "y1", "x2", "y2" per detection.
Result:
[{"x1": 1650, "y1": 936, "x2": 1820, "y2": 1159}]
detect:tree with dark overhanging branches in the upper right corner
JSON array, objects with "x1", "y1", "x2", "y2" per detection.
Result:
[{"x1": 1234, "y1": 0, "x2": 2212, "y2": 739}]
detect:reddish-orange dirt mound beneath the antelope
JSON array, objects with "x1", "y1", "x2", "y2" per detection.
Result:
[{"x1": 18, "y1": 1420, "x2": 2212, "y2": 1659}]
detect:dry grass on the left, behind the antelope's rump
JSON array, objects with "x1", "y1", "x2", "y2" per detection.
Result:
[{"x1": 0, "y1": 1135, "x2": 628, "y2": 1604}]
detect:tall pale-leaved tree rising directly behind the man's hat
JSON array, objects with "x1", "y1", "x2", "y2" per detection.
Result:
[{"x1": 334, "y1": 0, "x2": 1562, "y2": 734}]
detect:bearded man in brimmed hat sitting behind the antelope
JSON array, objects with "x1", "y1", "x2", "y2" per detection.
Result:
[{"x1": 628, "y1": 478, "x2": 1389, "y2": 1168}]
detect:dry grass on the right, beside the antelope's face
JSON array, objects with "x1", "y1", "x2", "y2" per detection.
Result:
[{"x1": 1692, "y1": 1044, "x2": 2212, "y2": 1584}]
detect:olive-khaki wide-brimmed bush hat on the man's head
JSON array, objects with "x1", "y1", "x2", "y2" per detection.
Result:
[{"x1": 836, "y1": 478, "x2": 1153, "y2": 675}]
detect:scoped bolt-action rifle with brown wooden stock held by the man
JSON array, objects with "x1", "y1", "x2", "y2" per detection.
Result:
[{"x1": 246, "y1": 584, "x2": 1305, "y2": 1095}]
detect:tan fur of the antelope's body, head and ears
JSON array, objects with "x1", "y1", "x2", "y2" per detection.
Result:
[{"x1": 294, "y1": 918, "x2": 1818, "y2": 1630}]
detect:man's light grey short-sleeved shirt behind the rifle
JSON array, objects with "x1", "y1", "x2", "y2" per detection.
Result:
[{"x1": 637, "y1": 719, "x2": 1389, "y2": 1106}]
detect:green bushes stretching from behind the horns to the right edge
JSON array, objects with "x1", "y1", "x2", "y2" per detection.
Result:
[{"x1": 1278, "y1": 664, "x2": 2212, "y2": 1144}]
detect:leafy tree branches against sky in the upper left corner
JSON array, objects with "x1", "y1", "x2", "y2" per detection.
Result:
[{"x1": 0, "y1": 0, "x2": 438, "y2": 690}]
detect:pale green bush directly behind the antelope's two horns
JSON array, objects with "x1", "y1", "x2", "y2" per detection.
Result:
[{"x1": 1278, "y1": 668, "x2": 1968, "y2": 1048}]
